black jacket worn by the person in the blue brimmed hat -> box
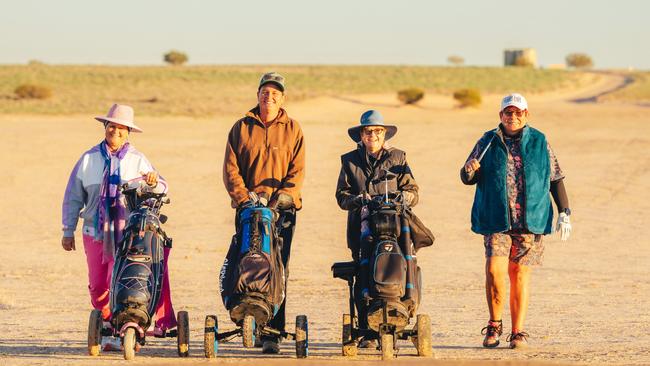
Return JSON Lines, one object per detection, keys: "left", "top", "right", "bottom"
{"left": 336, "top": 144, "right": 418, "bottom": 251}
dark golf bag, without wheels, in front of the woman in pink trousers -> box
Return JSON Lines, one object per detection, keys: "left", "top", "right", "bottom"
{"left": 110, "top": 185, "right": 172, "bottom": 329}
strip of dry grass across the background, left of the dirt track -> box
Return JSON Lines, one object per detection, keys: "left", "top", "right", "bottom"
{"left": 0, "top": 64, "right": 581, "bottom": 117}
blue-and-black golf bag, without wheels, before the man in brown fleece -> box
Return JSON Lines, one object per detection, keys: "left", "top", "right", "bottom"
{"left": 219, "top": 202, "right": 285, "bottom": 325}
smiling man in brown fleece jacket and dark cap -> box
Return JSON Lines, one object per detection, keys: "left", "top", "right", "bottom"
{"left": 223, "top": 72, "right": 305, "bottom": 353}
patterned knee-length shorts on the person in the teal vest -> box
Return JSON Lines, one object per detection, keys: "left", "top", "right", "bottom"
{"left": 483, "top": 231, "right": 544, "bottom": 266}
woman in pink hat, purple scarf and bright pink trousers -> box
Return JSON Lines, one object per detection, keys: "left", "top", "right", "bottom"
{"left": 61, "top": 104, "right": 176, "bottom": 350}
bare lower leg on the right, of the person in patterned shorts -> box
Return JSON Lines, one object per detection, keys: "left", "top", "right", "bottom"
{"left": 508, "top": 262, "right": 531, "bottom": 333}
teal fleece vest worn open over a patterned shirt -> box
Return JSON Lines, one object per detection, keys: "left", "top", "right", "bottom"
{"left": 472, "top": 126, "right": 553, "bottom": 235}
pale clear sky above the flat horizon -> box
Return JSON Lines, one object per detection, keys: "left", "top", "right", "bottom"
{"left": 0, "top": 0, "right": 650, "bottom": 69}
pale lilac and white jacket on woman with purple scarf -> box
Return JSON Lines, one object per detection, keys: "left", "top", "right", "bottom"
{"left": 63, "top": 145, "right": 167, "bottom": 240}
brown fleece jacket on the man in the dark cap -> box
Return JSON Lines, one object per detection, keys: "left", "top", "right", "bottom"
{"left": 223, "top": 106, "right": 305, "bottom": 210}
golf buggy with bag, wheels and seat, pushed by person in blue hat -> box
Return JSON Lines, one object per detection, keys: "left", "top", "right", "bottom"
{"left": 332, "top": 193, "right": 433, "bottom": 360}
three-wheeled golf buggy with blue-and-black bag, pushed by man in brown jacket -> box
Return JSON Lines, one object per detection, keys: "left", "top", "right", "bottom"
{"left": 204, "top": 194, "right": 309, "bottom": 358}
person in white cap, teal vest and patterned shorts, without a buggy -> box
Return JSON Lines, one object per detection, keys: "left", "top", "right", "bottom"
{"left": 460, "top": 93, "right": 571, "bottom": 349}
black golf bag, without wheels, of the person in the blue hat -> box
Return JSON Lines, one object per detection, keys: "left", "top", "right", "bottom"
{"left": 359, "top": 199, "right": 422, "bottom": 330}
